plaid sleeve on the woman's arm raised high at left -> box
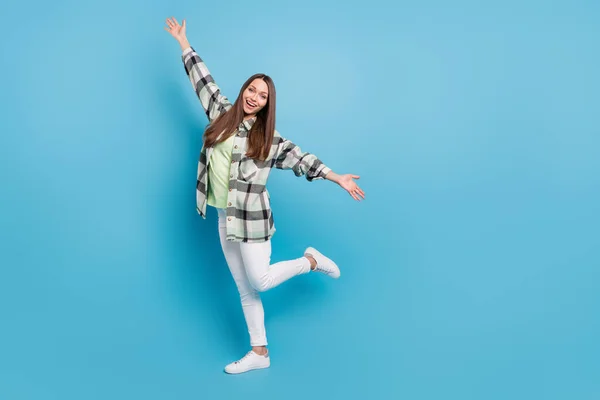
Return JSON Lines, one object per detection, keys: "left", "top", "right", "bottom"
{"left": 181, "top": 47, "right": 231, "bottom": 123}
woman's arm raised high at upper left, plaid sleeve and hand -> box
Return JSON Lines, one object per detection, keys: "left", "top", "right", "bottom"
{"left": 165, "top": 18, "right": 231, "bottom": 123}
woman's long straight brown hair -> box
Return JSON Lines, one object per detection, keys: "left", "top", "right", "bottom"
{"left": 204, "top": 74, "right": 275, "bottom": 161}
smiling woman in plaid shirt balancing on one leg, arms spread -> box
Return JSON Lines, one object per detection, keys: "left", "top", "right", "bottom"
{"left": 165, "top": 18, "right": 365, "bottom": 374}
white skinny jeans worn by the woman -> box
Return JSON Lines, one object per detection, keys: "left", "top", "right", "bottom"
{"left": 217, "top": 208, "right": 310, "bottom": 346}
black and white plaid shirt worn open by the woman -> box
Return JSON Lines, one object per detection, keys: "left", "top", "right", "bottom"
{"left": 181, "top": 47, "right": 331, "bottom": 243}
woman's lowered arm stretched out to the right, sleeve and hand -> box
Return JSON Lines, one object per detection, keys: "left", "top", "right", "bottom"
{"left": 273, "top": 131, "right": 365, "bottom": 201}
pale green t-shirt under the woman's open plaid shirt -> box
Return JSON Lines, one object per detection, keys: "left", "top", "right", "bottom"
{"left": 206, "top": 135, "right": 235, "bottom": 208}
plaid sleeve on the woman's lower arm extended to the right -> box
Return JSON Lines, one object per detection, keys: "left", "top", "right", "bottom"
{"left": 273, "top": 135, "right": 331, "bottom": 182}
